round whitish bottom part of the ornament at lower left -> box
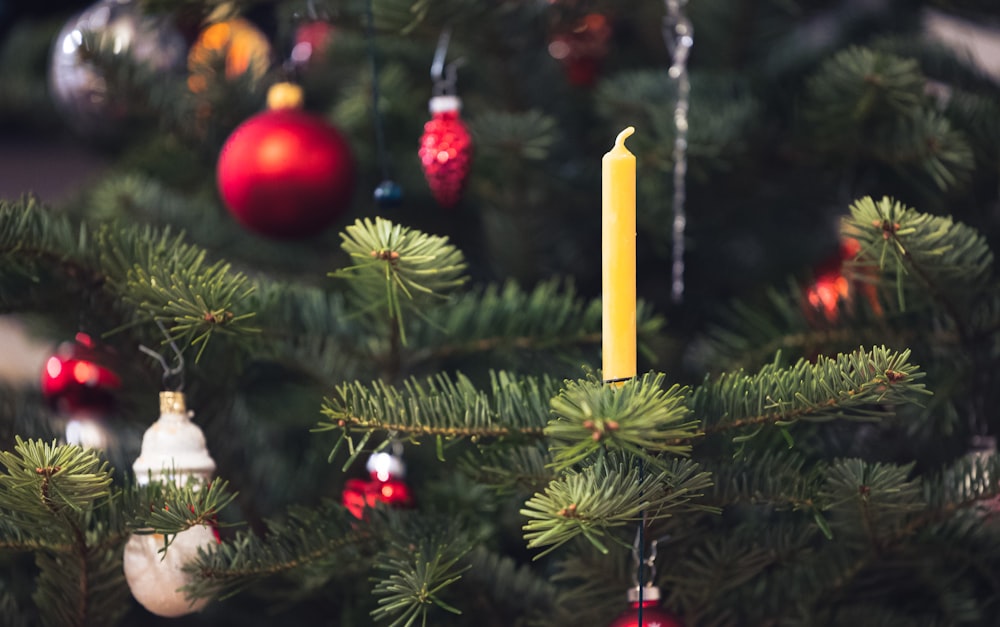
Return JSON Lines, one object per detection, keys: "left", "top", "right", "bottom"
{"left": 122, "top": 525, "right": 217, "bottom": 618}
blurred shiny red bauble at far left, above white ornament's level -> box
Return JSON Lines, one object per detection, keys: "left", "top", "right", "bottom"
{"left": 42, "top": 333, "right": 121, "bottom": 415}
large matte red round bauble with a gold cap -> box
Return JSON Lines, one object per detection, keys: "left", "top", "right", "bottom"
{"left": 216, "top": 109, "right": 355, "bottom": 239}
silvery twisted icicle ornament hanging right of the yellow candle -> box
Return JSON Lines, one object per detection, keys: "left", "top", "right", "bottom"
{"left": 663, "top": 0, "right": 694, "bottom": 303}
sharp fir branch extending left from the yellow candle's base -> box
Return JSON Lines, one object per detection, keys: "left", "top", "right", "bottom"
{"left": 316, "top": 371, "right": 557, "bottom": 463}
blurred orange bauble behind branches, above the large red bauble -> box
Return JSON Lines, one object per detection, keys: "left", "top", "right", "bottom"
{"left": 187, "top": 17, "right": 271, "bottom": 94}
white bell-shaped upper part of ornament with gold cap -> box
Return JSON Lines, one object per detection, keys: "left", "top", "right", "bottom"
{"left": 132, "top": 392, "right": 215, "bottom": 487}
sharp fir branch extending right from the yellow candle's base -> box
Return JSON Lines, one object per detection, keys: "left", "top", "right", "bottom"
{"left": 689, "top": 347, "right": 929, "bottom": 438}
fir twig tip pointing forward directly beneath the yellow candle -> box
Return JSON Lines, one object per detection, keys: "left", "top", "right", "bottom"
{"left": 545, "top": 373, "right": 698, "bottom": 470}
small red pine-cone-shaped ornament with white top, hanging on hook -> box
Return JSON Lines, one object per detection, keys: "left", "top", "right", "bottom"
{"left": 417, "top": 95, "right": 472, "bottom": 209}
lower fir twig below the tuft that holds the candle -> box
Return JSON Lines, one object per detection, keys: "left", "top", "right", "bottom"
{"left": 521, "top": 456, "right": 713, "bottom": 559}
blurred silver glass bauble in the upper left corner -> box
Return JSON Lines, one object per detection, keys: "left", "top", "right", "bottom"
{"left": 49, "top": 0, "right": 187, "bottom": 138}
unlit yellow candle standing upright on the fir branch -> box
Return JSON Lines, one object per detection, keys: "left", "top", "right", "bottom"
{"left": 601, "top": 126, "right": 636, "bottom": 382}
